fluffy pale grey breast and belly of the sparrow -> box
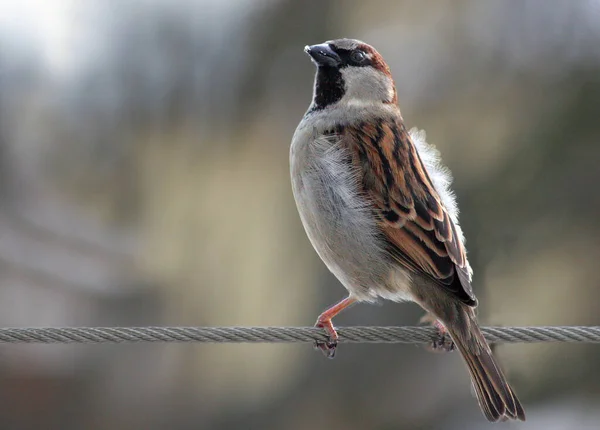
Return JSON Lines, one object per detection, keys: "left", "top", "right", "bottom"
{"left": 290, "top": 124, "right": 390, "bottom": 301}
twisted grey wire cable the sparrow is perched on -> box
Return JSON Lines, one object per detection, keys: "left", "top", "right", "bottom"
{"left": 0, "top": 326, "right": 600, "bottom": 344}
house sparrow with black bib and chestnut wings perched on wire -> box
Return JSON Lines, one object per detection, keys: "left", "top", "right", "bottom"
{"left": 290, "top": 39, "right": 525, "bottom": 421}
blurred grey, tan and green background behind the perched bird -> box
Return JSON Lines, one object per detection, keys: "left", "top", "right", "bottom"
{"left": 0, "top": 0, "right": 600, "bottom": 430}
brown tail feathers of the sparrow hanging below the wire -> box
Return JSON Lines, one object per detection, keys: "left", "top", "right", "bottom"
{"left": 446, "top": 318, "right": 525, "bottom": 422}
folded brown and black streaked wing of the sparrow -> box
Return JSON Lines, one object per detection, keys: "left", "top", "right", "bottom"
{"left": 342, "top": 119, "right": 477, "bottom": 306}
